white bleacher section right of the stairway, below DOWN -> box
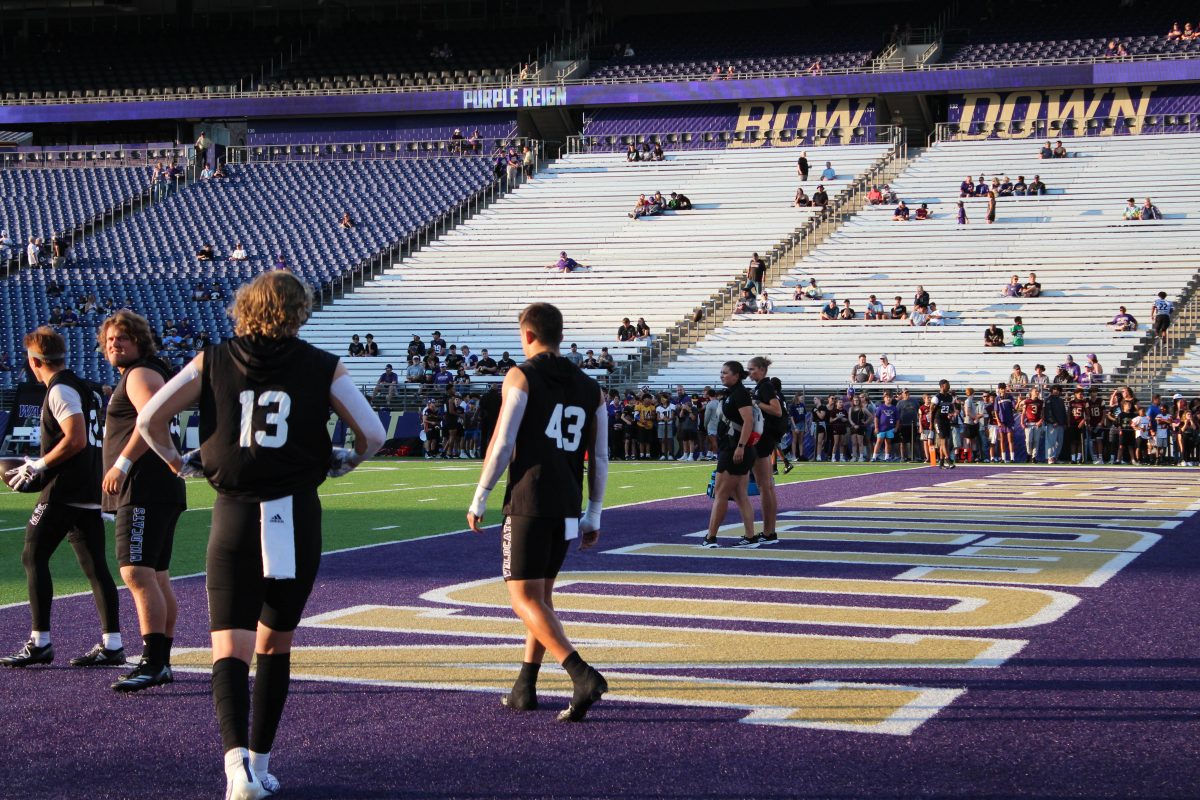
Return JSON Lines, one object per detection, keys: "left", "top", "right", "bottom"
{"left": 650, "top": 136, "right": 1200, "bottom": 389}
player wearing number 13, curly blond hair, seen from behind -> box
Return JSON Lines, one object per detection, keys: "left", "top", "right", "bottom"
{"left": 138, "top": 271, "right": 384, "bottom": 800}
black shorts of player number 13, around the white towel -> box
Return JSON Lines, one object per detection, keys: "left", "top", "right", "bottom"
{"left": 208, "top": 489, "right": 320, "bottom": 631}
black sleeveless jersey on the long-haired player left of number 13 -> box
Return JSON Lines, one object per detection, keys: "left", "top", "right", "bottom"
{"left": 102, "top": 356, "right": 187, "bottom": 512}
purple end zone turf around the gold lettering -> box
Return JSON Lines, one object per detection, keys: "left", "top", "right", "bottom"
{"left": 0, "top": 468, "right": 1200, "bottom": 798}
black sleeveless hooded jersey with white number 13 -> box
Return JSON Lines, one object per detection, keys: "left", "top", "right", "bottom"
{"left": 200, "top": 336, "right": 337, "bottom": 500}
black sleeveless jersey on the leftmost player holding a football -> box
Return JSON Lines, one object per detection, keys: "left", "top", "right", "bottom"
{"left": 37, "top": 369, "right": 103, "bottom": 506}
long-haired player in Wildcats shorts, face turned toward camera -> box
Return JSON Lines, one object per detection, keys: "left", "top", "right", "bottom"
{"left": 97, "top": 309, "right": 187, "bottom": 692}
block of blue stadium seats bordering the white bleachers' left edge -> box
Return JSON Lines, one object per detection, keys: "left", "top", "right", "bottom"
{"left": 0, "top": 157, "right": 492, "bottom": 385}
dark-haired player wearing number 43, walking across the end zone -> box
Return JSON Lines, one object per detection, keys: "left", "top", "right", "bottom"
{"left": 467, "top": 302, "right": 608, "bottom": 722}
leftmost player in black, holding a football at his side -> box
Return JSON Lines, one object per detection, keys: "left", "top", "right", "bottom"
{"left": 0, "top": 326, "right": 125, "bottom": 667}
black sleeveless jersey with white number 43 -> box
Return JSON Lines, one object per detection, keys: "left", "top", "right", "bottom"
{"left": 504, "top": 353, "right": 600, "bottom": 519}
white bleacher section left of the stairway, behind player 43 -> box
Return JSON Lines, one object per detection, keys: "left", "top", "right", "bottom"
{"left": 304, "top": 145, "right": 888, "bottom": 385}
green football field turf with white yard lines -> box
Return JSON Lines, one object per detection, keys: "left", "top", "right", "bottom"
{"left": 0, "top": 459, "right": 902, "bottom": 606}
